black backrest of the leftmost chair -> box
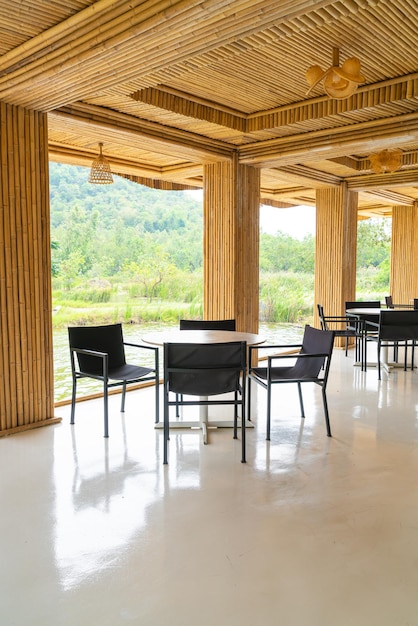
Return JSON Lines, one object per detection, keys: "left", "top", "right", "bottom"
{"left": 68, "top": 324, "right": 126, "bottom": 373}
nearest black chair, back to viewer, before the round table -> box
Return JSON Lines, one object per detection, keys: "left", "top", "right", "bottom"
{"left": 163, "top": 341, "right": 247, "bottom": 464}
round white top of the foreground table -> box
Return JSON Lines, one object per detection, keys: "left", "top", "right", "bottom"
{"left": 142, "top": 330, "right": 265, "bottom": 346}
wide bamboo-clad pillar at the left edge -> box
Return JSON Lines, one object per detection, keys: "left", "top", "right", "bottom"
{"left": 0, "top": 103, "right": 57, "bottom": 435}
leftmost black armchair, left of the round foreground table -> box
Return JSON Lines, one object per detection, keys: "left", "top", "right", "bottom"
{"left": 68, "top": 324, "right": 159, "bottom": 437}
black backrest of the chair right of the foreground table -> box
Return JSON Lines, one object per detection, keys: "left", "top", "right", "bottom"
{"left": 294, "top": 325, "right": 334, "bottom": 378}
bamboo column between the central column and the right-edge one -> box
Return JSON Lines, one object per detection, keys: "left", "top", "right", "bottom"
{"left": 314, "top": 184, "right": 357, "bottom": 346}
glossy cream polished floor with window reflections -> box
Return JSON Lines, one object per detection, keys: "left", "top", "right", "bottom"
{"left": 0, "top": 351, "right": 418, "bottom": 626}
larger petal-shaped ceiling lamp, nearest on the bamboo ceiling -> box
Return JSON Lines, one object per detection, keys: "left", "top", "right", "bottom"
{"left": 306, "top": 48, "right": 366, "bottom": 100}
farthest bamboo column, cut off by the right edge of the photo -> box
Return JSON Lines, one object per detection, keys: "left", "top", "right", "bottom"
{"left": 390, "top": 202, "right": 418, "bottom": 304}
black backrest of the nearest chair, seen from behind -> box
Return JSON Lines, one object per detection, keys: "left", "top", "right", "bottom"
{"left": 164, "top": 341, "right": 247, "bottom": 396}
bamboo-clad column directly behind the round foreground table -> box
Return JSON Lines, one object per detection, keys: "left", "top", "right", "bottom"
{"left": 204, "top": 158, "right": 260, "bottom": 333}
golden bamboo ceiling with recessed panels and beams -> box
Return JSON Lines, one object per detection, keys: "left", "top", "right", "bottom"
{"left": 0, "top": 0, "right": 418, "bottom": 216}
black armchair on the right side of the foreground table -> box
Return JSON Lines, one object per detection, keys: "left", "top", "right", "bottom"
{"left": 248, "top": 326, "right": 334, "bottom": 440}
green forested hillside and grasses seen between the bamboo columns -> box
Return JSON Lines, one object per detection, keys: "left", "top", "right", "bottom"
{"left": 50, "top": 163, "right": 391, "bottom": 326}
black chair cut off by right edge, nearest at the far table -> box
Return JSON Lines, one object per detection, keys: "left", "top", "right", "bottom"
{"left": 365, "top": 310, "right": 418, "bottom": 380}
